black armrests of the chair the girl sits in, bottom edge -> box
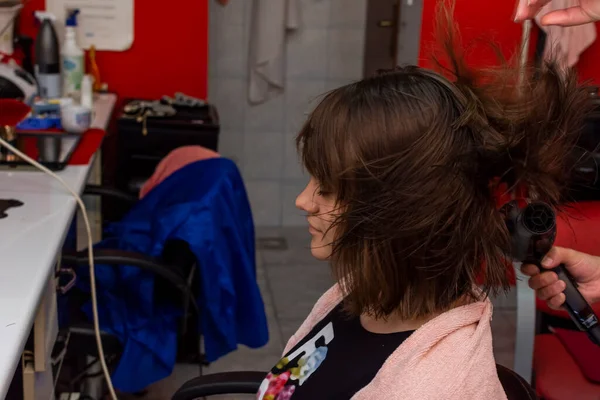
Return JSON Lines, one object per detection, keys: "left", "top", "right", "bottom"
{"left": 171, "top": 365, "right": 538, "bottom": 400}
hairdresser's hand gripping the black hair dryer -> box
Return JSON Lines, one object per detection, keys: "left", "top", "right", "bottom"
{"left": 521, "top": 247, "right": 600, "bottom": 308}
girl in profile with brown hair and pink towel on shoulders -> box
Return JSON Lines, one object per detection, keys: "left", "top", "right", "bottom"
{"left": 258, "top": 3, "right": 588, "bottom": 400}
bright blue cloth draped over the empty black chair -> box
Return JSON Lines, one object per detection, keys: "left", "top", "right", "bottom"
{"left": 72, "top": 158, "right": 268, "bottom": 393}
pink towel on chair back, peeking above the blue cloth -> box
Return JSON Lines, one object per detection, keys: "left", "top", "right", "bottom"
{"left": 140, "top": 146, "right": 220, "bottom": 199}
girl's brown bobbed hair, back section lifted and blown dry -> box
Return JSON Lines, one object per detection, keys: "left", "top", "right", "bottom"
{"left": 297, "top": 0, "right": 589, "bottom": 318}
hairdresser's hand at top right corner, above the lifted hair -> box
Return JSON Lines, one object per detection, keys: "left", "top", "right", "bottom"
{"left": 515, "top": 0, "right": 600, "bottom": 26}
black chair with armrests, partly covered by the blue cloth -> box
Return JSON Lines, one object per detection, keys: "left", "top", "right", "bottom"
{"left": 58, "top": 186, "right": 203, "bottom": 399}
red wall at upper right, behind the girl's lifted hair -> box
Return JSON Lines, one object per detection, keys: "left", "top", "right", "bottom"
{"left": 419, "top": 0, "right": 600, "bottom": 84}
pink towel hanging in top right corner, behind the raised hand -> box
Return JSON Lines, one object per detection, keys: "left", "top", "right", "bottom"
{"left": 536, "top": 0, "right": 596, "bottom": 67}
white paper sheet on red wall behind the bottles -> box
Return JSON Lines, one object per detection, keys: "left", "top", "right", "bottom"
{"left": 46, "top": 0, "right": 134, "bottom": 51}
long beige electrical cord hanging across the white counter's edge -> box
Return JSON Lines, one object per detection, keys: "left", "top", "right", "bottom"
{"left": 0, "top": 138, "right": 118, "bottom": 400}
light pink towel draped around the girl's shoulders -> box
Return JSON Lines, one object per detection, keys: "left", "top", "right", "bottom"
{"left": 284, "top": 285, "right": 506, "bottom": 400}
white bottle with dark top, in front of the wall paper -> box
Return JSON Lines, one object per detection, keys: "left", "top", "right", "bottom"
{"left": 61, "top": 10, "right": 85, "bottom": 97}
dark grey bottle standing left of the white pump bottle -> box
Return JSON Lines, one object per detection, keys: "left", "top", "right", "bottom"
{"left": 34, "top": 11, "right": 62, "bottom": 99}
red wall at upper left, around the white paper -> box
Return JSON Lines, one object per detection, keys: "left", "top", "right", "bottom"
{"left": 21, "top": 0, "right": 208, "bottom": 98}
